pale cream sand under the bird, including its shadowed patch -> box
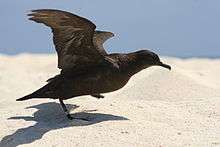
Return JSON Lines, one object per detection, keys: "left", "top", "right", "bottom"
{"left": 0, "top": 54, "right": 220, "bottom": 147}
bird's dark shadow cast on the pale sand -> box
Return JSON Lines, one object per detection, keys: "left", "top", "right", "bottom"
{"left": 0, "top": 102, "right": 128, "bottom": 147}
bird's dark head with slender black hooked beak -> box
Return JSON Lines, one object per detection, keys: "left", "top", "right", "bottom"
{"left": 134, "top": 50, "right": 171, "bottom": 70}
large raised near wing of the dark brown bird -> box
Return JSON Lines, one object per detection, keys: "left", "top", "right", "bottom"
{"left": 28, "top": 9, "right": 104, "bottom": 69}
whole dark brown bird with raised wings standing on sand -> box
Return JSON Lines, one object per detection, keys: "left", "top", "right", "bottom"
{"left": 17, "top": 9, "right": 171, "bottom": 119}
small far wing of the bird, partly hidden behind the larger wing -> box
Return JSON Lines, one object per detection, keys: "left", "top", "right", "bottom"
{"left": 93, "top": 31, "right": 114, "bottom": 55}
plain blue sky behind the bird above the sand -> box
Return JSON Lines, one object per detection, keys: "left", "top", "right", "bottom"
{"left": 0, "top": 0, "right": 220, "bottom": 57}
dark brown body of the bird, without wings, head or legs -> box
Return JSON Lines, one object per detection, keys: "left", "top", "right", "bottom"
{"left": 18, "top": 54, "right": 145, "bottom": 100}
